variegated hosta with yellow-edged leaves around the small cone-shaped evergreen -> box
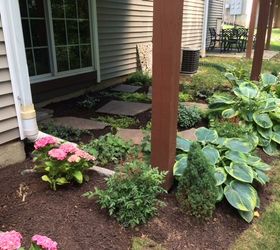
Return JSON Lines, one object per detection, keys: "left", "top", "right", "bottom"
{"left": 173, "top": 127, "right": 270, "bottom": 222}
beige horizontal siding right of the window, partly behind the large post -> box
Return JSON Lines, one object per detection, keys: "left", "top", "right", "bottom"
{"left": 97, "top": 0, "right": 204, "bottom": 80}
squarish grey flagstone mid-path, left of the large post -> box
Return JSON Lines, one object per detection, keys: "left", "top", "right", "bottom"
{"left": 96, "top": 100, "right": 152, "bottom": 116}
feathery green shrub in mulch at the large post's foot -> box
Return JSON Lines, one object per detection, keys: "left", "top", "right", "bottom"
{"left": 85, "top": 161, "right": 165, "bottom": 227}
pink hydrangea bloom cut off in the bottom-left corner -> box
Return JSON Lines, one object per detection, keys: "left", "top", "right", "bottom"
{"left": 0, "top": 231, "right": 22, "bottom": 250}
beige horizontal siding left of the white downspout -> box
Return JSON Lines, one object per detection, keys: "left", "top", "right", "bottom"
{"left": 0, "top": 17, "right": 19, "bottom": 145}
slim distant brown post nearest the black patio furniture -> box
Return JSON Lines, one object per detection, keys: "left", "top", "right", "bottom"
{"left": 246, "top": 0, "right": 259, "bottom": 59}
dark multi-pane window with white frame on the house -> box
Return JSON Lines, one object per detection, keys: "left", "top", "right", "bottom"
{"left": 19, "top": 0, "right": 93, "bottom": 79}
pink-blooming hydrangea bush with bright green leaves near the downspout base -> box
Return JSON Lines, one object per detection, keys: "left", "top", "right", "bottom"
{"left": 33, "top": 136, "right": 95, "bottom": 190}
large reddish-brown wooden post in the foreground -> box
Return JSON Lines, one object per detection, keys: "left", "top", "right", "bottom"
{"left": 152, "top": 0, "right": 184, "bottom": 189}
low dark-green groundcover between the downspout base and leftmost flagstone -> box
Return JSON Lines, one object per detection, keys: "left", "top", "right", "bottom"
{"left": 39, "top": 122, "right": 90, "bottom": 142}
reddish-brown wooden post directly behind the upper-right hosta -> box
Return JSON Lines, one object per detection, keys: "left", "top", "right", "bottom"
{"left": 251, "top": 0, "right": 270, "bottom": 81}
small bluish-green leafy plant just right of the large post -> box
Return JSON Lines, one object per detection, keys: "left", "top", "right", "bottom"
{"left": 178, "top": 104, "right": 202, "bottom": 128}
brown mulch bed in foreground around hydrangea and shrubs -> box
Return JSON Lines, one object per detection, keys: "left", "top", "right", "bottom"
{"left": 0, "top": 155, "right": 276, "bottom": 250}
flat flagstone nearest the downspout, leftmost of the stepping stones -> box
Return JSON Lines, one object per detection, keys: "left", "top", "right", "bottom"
{"left": 43, "top": 116, "right": 109, "bottom": 130}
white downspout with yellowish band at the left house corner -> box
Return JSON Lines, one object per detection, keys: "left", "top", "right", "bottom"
{"left": 0, "top": 0, "right": 39, "bottom": 141}
